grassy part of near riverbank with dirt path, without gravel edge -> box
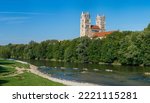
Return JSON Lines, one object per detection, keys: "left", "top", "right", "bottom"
{"left": 0, "top": 59, "right": 63, "bottom": 86}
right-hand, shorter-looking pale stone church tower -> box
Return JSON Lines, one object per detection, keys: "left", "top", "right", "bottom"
{"left": 96, "top": 15, "right": 106, "bottom": 32}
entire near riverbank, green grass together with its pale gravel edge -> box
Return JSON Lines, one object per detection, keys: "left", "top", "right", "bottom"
{"left": 0, "top": 59, "right": 99, "bottom": 86}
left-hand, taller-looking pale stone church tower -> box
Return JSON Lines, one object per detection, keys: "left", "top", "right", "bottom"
{"left": 80, "top": 12, "right": 91, "bottom": 37}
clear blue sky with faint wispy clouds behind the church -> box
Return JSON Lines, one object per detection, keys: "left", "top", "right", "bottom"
{"left": 0, "top": 0, "right": 150, "bottom": 45}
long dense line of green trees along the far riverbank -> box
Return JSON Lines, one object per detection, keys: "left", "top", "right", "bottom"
{"left": 0, "top": 25, "right": 150, "bottom": 65}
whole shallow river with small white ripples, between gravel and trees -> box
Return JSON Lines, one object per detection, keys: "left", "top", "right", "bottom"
{"left": 26, "top": 60, "right": 150, "bottom": 86}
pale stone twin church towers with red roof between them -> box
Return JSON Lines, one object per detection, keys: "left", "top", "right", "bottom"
{"left": 80, "top": 12, "right": 105, "bottom": 38}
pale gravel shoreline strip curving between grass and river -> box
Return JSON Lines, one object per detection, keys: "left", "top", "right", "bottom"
{"left": 15, "top": 60, "right": 100, "bottom": 86}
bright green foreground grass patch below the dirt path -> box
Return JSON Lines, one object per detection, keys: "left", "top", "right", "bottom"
{"left": 1, "top": 72, "right": 63, "bottom": 86}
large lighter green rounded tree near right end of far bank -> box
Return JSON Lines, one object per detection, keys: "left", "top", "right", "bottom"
{"left": 118, "top": 32, "right": 142, "bottom": 65}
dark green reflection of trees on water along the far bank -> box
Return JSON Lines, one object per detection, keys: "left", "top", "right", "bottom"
{"left": 25, "top": 60, "right": 150, "bottom": 73}
